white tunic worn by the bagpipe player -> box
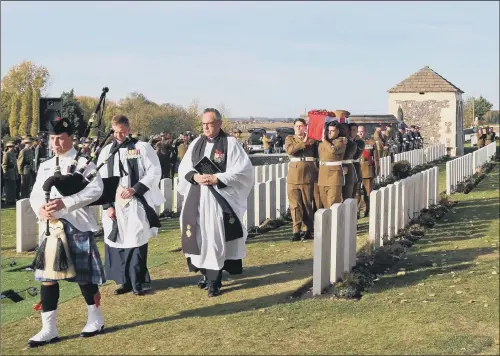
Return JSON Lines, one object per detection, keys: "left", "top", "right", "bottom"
{"left": 30, "top": 148, "right": 103, "bottom": 237}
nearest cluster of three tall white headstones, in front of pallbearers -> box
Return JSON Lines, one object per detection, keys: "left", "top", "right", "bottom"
{"left": 312, "top": 199, "right": 358, "bottom": 295}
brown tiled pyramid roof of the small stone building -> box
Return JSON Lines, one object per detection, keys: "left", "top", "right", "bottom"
{"left": 388, "top": 66, "right": 463, "bottom": 93}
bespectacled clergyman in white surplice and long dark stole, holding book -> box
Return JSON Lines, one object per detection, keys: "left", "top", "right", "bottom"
{"left": 177, "top": 108, "right": 254, "bottom": 297}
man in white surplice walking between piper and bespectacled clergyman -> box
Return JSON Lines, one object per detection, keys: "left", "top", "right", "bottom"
{"left": 98, "top": 115, "right": 165, "bottom": 295}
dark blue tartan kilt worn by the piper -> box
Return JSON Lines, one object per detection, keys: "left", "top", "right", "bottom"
{"left": 35, "top": 219, "right": 106, "bottom": 285}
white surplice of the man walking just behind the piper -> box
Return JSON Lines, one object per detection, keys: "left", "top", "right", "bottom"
{"left": 97, "top": 141, "right": 165, "bottom": 248}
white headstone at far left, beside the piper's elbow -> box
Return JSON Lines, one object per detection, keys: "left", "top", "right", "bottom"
{"left": 16, "top": 199, "right": 38, "bottom": 253}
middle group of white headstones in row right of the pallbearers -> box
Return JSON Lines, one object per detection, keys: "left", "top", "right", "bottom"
{"left": 368, "top": 167, "right": 439, "bottom": 249}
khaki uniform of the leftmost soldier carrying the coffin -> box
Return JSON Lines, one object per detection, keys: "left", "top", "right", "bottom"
{"left": 285, "top": 135, "right": 318, "bottom": 233}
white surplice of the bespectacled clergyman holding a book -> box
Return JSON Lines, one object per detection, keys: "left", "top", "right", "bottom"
{"left": 177, "top": 137, "right": 254, "bottom": 270}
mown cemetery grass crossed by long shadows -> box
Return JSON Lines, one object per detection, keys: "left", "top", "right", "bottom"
{"left": 1, "top": 144, "right": 500, "bottom": 355}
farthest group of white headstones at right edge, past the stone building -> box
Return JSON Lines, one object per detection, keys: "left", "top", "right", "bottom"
{"left": 446, "top": 142, "right": 496, "bottom": 195}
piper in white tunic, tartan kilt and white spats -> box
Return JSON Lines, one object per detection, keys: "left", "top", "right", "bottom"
{"left": 28, "top": 117, "right": 105, "bottom": 347}
